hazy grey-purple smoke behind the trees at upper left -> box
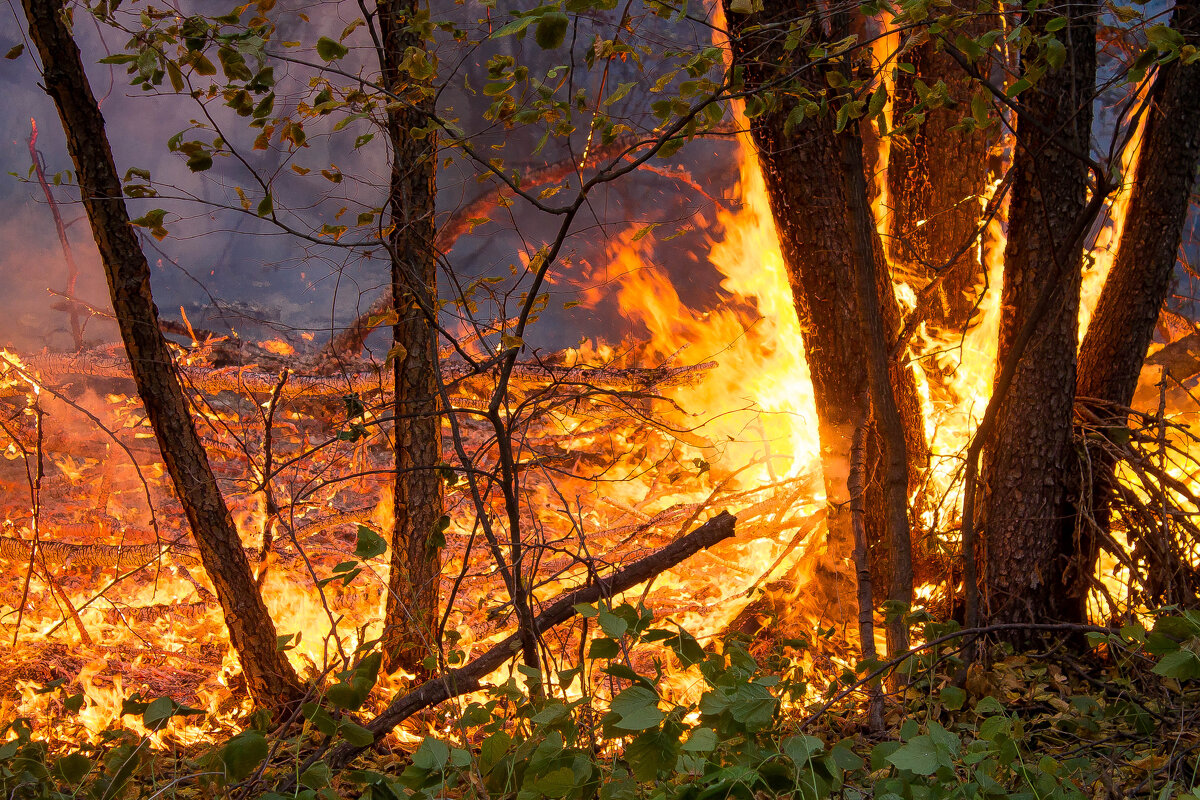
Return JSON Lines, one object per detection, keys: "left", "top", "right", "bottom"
{"left": 0, "top": 1, "right": 736, "bottom": 351}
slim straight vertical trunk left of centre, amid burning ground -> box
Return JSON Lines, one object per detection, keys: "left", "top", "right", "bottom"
{"left": 376, "top": 0, "right": 443, "bottom": 676}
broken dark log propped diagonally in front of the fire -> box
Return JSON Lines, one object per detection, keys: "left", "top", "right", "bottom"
{"left": 304, "top": 511, "right": 737, "bottom": 774}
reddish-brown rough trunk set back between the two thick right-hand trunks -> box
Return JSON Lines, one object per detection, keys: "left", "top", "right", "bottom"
{"left": 888, "top": 16, "right": 998, "bottom": 331}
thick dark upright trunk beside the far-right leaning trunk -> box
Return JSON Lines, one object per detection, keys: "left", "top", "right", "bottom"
{"left": 983, "top": 2, "right": 1098, "bottom": 622}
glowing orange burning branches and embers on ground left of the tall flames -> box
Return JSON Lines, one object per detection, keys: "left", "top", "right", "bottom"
{"left": 0, "top": 338, "right": 816, "bottom": 730}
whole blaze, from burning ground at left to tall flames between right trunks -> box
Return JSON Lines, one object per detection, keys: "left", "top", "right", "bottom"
{"left": 0, "top": 120, "right": 1196, "bottom": 742}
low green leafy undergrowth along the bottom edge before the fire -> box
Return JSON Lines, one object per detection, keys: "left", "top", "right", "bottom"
{"left": 0, "top": 604, "right": 1200, "bottom": 800}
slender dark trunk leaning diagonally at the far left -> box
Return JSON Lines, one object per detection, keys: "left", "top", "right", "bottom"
{"left": 22, "top": 0, "right": 304, "bottom": 708}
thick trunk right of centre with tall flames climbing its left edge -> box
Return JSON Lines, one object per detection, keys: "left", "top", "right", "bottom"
{"left": 725, "top": 0, "right": 928, "bottom": 652}
